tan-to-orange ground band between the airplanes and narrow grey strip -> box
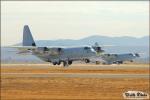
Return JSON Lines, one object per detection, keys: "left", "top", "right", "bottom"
{"left": 1, "top": 64, "right": 149, "bottom": 74}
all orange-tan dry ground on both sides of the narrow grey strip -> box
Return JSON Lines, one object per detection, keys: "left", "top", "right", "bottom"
{"left": 1, "top": 64, "right": 150, "bottom": 100}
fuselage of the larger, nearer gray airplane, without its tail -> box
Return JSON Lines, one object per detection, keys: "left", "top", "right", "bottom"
{"left": 32, "top": 47, "right": 96, "bottom": 65}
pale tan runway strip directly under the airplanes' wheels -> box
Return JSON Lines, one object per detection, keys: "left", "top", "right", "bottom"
{"left": 1, "top": 64, "right": 149, "bottom": 70}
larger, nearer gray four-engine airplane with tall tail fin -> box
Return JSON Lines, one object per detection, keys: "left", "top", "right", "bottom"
{"left": 17, "top": 25, "right": 101, "bottom": 66}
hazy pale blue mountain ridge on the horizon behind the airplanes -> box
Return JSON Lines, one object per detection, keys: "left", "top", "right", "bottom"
{"left": 17, "top": 35, "right": 149, "bottom": 46}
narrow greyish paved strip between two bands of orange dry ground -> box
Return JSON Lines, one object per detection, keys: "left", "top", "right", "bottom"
{"left": 1, "top": 73, "right": 149, "bottom": 79}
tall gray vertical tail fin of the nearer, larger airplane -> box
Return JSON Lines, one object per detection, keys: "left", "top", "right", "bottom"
{"left": 22, "top": 25, "right": 36, "bottom": 46}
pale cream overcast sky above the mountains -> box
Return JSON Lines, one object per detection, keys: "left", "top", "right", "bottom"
{"left": 1, "top": 1, "right": 149, "bottom": 45}
